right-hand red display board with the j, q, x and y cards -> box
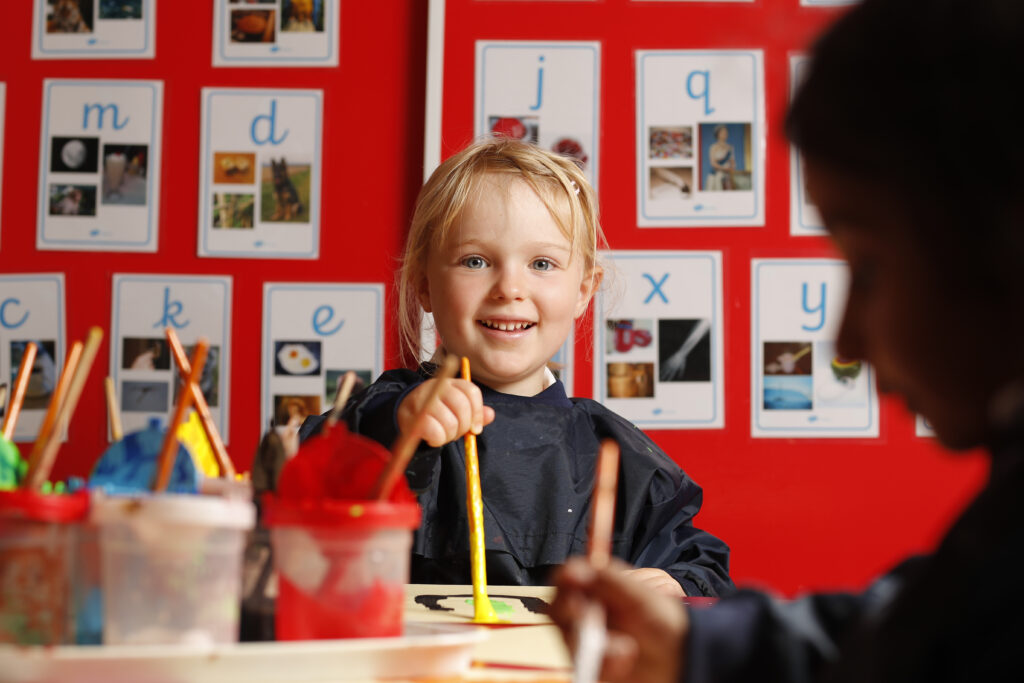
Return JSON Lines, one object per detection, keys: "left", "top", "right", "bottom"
{"left": 426, "top": 0, "right": 984, "bottom": 593}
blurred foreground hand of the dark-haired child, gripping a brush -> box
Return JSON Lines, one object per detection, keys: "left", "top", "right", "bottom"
{"left": 550, "top": 558, "right": 689, "bottom": 683}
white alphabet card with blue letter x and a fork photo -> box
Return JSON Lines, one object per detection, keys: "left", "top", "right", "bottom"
{"left": 594, "top": 251, "right": 725, "bottom": 429}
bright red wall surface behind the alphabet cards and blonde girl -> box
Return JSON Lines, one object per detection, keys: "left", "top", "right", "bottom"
{"left": 0, "top": 0, "right": 985, "bottom": 594}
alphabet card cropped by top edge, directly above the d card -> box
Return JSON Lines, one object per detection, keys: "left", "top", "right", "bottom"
{"left": 213, "top": 0, "right": 340, "bottom": 67}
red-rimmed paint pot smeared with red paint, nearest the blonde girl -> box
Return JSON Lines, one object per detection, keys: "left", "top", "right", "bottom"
{"left": 263, "top": 496, "right": 420, "bottom": 640}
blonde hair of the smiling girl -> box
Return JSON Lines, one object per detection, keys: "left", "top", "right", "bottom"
{"left": 398, "top": 137, "right": 606, "bottom": 365}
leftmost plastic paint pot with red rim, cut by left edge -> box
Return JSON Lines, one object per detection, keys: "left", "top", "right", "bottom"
{"left": 0, "top": 489, "right": 89, "bottom": 645}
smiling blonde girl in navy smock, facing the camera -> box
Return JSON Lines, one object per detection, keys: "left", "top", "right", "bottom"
{"left": 317, "top": 138, "right": 732, "bottom": 596}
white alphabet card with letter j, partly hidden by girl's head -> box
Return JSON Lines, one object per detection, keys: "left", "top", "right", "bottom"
{"left": 474, "top": 40, "right": 601, "bottom": 186}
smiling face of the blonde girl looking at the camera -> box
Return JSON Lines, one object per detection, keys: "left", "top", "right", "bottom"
{"left": 420, "top": 173, "right": 600, "bottom": 396}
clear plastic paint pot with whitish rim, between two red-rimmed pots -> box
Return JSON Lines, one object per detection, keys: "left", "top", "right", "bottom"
{"left": 92, "top": 494, "right": 256, "bottom": 645}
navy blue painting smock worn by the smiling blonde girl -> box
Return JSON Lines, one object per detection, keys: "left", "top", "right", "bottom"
{"left": 303, "top": 366, "right": 733, "bottom": 596}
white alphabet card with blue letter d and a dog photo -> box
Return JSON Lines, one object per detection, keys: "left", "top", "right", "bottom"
{"left": 199, "top": 88, "right": 324, "bottom": 259}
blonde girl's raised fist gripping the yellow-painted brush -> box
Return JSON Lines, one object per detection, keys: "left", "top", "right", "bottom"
{"left": 397, "top": 379, "right": 495, "bottom": 447}
